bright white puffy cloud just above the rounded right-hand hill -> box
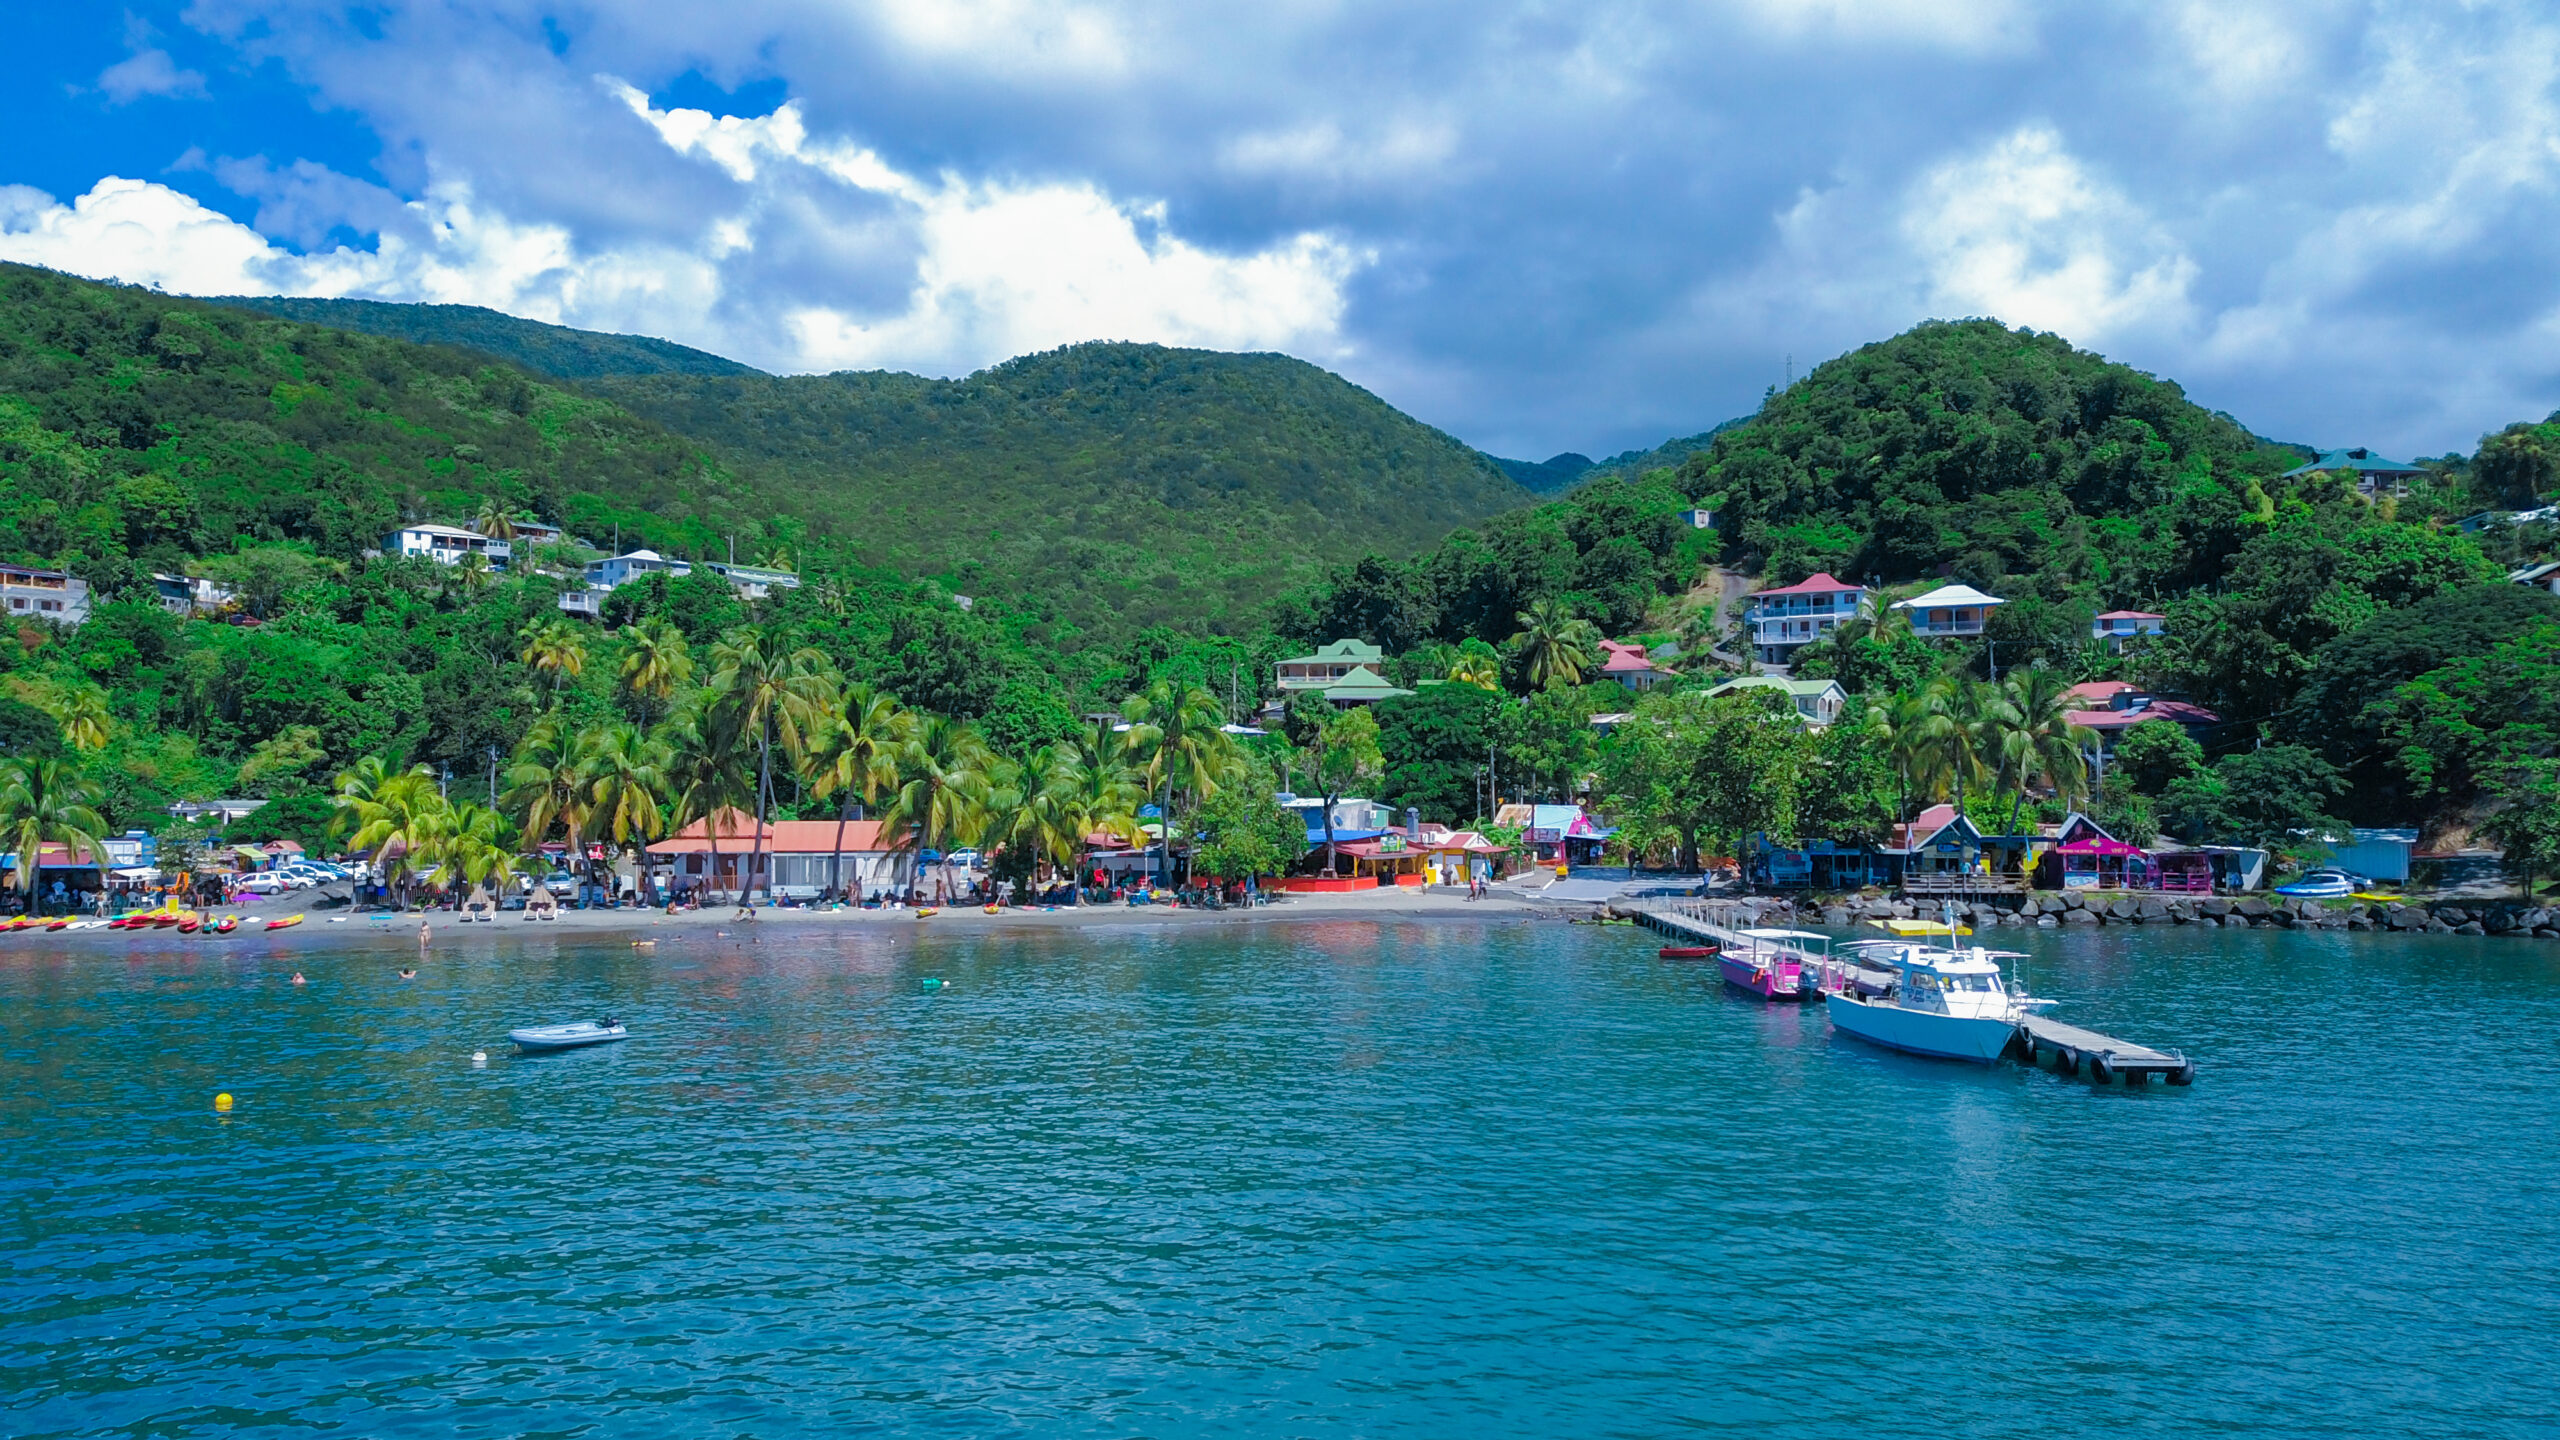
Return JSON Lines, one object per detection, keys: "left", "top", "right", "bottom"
{"left": 1900, "top": 126, "right": 2196, "bottom": 343}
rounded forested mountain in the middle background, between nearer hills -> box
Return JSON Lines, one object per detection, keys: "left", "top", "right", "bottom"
{"left": 589, "top": 343, "right": 1528, "bottom": 630}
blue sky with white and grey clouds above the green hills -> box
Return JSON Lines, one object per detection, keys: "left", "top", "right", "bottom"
{"left": 0, "top": 0, "right": 2560, "bottom": 459}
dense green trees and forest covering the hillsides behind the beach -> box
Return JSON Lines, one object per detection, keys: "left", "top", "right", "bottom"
{"left": 0, "top": 266, "right": 2560, "bottom": 881}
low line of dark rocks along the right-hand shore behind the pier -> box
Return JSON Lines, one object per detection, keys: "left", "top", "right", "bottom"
{"left": 1802, "top": 889, "right": 2560, "bottom": 940}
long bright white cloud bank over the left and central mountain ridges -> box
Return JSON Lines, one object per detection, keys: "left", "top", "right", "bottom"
{"left": 0, "top": 82, "right": 1367, "bottom": 372}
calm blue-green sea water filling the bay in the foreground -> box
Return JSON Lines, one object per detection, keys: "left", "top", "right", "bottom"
{"left": 0, "top": 922, "right": 2560, "bottom": 1440}
